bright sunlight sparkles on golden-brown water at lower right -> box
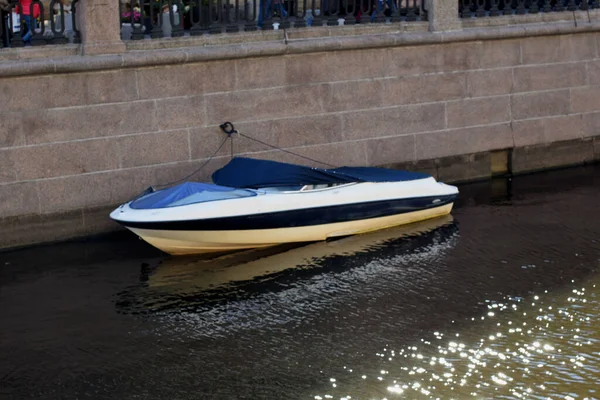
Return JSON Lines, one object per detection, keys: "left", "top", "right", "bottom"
{"left": 315, "top": 282, "right": 600, "bottom": 399}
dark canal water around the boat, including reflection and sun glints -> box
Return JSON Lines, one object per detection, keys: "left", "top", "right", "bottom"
{"left": 0, "top": 166, "right": 600, "bottom": 400}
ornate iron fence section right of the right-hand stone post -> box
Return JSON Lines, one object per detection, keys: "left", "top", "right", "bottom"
{"left": 459, "top": 0, "right": 600, "bottom": 18}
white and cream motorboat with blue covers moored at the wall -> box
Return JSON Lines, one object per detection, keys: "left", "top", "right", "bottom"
{"left": 110, "top": 157, "right": 458, "bottom": 255}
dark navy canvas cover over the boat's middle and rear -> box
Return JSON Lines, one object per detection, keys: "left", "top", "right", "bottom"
{"left": 212, "top": 157, "right": 431, "bottom": 189}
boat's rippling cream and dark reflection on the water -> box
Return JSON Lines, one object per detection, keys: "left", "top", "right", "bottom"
{"left": 119, "top": 215, "right": 458, "bottom": 313}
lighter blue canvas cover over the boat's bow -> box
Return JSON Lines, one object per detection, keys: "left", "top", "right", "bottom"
{"left": 129, "top": 182, "right": 256, "bottom": 210}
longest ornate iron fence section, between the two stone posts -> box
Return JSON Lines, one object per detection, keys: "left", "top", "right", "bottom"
{"left": 120, "top": 0, "right": 427, "bottom": 40}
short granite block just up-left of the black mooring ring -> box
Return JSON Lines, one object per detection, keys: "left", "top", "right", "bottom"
{"left": 156, "top": 96, "right": 206, "bottom": 130}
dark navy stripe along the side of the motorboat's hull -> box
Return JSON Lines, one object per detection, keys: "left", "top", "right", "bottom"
{"left": 117, "top": 195, "right": 456, "bottom": 231}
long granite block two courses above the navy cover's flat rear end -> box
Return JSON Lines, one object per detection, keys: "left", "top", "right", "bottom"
{"left": 342, "top": 103, "right": 446, "bottom": 140}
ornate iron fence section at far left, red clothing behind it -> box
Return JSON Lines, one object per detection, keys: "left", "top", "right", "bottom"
{"left": 0, "top": 0, "right": 81, "bottom": 47}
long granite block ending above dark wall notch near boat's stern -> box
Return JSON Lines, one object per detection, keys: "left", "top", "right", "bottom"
{"left": 415, "top": 124, "right": 513, "bottom": 160}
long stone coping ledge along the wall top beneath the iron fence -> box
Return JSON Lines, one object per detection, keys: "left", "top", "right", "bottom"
{"left": 0, "top": 18, "right": 600, "bottom": 77}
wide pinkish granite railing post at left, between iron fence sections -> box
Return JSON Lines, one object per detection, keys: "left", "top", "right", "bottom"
{"left": 77, "top": 0, "right": 125, "bottom": 55}
